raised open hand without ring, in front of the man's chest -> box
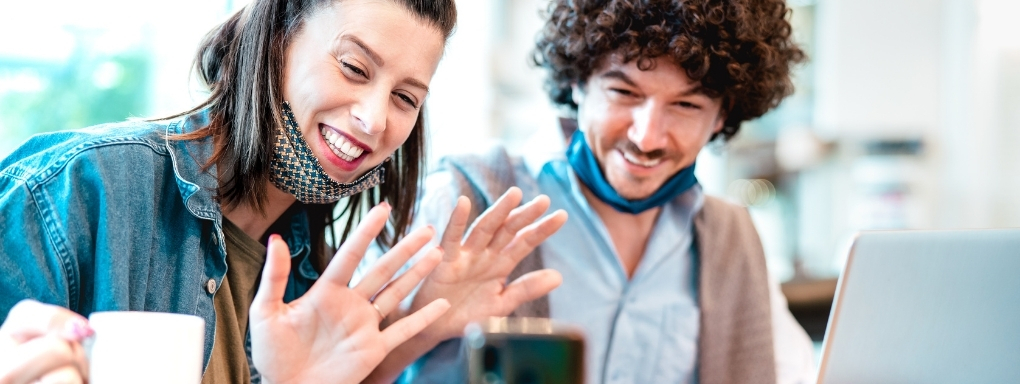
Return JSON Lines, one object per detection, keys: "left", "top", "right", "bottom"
{"left": 366, "top": 187, "right": 567, "bottom": 383}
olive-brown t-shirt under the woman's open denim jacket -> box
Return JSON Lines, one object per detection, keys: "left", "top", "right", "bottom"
{"left": 202, "top": 218, "right": 266, "bottom": 384}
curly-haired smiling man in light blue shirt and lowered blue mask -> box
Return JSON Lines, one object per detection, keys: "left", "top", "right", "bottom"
{"left": 359, "top": 0, "right": 814, "bottom": 383}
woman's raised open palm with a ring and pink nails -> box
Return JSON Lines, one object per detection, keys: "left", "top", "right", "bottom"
{"left": 250, "top": 203, "right": 450, "bottom": 384}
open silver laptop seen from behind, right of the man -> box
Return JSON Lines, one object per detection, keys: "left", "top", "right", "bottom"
{"left": 818, "top": 229, "right": 1020, "bottom": 384}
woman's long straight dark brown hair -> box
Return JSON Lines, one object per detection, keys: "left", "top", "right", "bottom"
{"left": 171, "top": 0, "right": 457, "bottom": 252}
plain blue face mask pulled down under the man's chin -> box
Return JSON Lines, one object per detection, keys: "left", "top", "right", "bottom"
{"left": 567, "top": 130, "right": 698, "bottom": 214}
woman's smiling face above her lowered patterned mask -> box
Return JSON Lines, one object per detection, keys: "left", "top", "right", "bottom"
{"left": 284, "top": 0, "right": 444, "bottom": 183}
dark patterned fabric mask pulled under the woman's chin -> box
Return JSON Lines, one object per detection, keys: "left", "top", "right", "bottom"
{"left": 270, "top": 102, "right": 389, "bottom": 204}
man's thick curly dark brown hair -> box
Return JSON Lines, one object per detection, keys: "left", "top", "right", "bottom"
{"left": 533, "top": 0, "right": 805, "bottom": 140}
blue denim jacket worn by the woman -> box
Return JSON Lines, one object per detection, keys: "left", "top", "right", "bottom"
{"left": 0, "top": 112, "right": 318, "bottom": 372}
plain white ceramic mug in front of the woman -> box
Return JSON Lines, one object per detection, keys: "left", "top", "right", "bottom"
{"left": 88, "top": 311, "right": 205, "bottom": 384}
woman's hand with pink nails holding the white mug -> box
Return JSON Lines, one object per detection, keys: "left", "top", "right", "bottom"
{"left": 0, "top": 300, "right": 94, "bottom": 384}
